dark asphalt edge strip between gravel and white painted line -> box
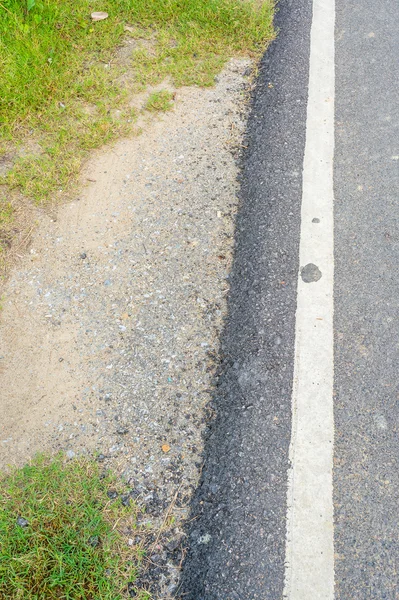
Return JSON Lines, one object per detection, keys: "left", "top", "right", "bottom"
{"left": 180, "top": 0, "right": 311, "bottom": 600}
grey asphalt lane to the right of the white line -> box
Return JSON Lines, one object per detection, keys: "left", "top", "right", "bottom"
{"left": 334, "top": 0, "right": 399, "bottom": 600}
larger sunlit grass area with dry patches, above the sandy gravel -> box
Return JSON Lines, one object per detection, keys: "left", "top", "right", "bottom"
{"left": 0, "top": 0, "right": 274, "bottom": 256}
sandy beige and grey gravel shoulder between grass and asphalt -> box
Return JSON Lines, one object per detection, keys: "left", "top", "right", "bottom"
{"left": 0, "top": 59, "right": 250, "bottom": 598}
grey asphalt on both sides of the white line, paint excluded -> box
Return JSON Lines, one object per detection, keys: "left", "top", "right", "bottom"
{"left": 180, "top": 0, "right": 399, "bottom": 600}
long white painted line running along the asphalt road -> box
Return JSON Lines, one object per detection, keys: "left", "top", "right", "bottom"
{"left": 284, "top": 0, "right": 335, "bottom": 600}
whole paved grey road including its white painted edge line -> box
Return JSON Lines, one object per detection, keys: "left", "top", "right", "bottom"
{"left": 180, "top": 0, "right": 399, "bottom": 600}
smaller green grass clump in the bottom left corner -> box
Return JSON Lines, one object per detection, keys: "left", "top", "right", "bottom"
{"left": 0, "top": 455, "right": 150, "bottom": 600}
